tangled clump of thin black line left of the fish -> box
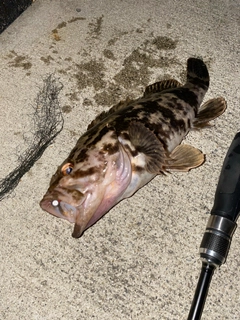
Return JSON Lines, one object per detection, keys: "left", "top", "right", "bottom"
{"left": 0, "top": 75, "right": 63, "bottom": 201}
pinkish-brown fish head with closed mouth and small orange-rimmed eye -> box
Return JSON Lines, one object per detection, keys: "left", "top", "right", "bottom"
{"left": 40, "top": 142, "right": 132, "bottom": 238}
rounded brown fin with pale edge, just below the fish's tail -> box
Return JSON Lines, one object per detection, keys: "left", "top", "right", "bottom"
{"left": 193, "top": 97, "right": 227, "bottom": 129}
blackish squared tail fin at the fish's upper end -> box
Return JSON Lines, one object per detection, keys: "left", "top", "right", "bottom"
{"left": 187, "top": 58, "right": 209, "bottom": 88}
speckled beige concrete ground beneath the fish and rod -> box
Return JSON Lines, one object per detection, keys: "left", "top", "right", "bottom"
{"left": 0, "top": 0, "right": 240, "bottom": 320}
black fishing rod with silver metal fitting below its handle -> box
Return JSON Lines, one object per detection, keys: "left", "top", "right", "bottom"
{"left": 187, "top": 132, "right": 240, "bottom": 320}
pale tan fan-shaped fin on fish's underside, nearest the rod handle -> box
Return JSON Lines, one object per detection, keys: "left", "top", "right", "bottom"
{"left": 165, "top": 144, "right": 205, "bottom": 171}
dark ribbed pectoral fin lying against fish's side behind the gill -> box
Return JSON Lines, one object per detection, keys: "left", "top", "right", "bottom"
{"left": 128, "top": 121, "right": 165, "bottom": 174}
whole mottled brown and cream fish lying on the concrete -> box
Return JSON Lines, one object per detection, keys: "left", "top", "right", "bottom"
{"left": 40, "top": 57, "right": 227, "bottom": 238}
